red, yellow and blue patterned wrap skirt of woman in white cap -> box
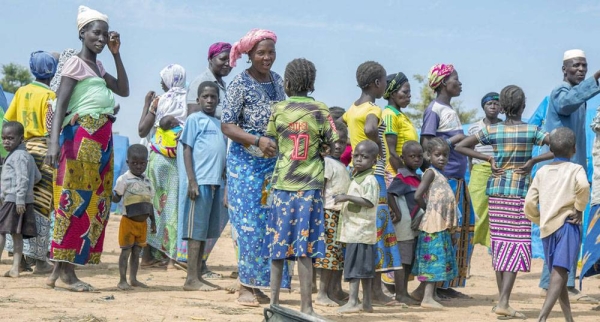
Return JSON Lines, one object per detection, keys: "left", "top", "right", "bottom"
{"left": 50, "top": 115, "right": 113, "bottom": 265}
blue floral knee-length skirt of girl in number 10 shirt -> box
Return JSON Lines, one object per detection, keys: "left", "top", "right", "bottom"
{"left": 263, "top": 189, "right": 325, "bottom": 259}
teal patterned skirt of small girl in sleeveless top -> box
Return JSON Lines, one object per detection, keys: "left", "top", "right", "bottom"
{"left": 412, "top": 230, "right": 458, "bottom": 282}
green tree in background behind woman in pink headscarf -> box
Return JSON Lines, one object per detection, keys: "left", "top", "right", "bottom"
{"left": 406, "top": 74, "right": 477, "bottom": 128}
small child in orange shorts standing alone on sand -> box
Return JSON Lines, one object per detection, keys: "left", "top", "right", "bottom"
{"left": 112, "top": 144, "right": 156, "bottom": 290}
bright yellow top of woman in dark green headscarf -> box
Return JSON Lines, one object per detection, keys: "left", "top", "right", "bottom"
{"left": 381, "top": 105, "right": 419, "bottom": 176}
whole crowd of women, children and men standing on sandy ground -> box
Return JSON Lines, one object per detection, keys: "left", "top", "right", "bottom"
{"left": 0, "top": 6, "right": 600, "bottom": 321}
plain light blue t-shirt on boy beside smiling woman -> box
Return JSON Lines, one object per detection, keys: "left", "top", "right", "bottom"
{"left": 177, "top": 112, "right": 227, "bottom": 185}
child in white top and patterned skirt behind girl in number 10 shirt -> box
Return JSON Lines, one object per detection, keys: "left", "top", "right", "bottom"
{"left": 314, "top": 121, "right": 351, "bottom": 306}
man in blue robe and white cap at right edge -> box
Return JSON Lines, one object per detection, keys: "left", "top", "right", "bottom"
{"left": 540, "top": 49, "right": 600, "bottom": 303}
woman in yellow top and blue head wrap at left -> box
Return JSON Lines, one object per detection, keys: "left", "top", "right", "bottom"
{"left": 4, "top": 51, "right": 58, "bottom": 274}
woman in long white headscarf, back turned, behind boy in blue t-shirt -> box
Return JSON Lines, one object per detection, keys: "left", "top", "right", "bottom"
{"left": 138, "top": 64, "right": 187, "bottom": 266}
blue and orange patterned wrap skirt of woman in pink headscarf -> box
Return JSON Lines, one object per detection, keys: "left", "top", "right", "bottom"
{"left": 439, "top": 179, "right": 475, "bottom": 288}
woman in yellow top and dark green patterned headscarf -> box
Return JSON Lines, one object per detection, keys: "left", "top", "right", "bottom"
{"left": 382, "top": 72, "right": 419, "bottom": 185}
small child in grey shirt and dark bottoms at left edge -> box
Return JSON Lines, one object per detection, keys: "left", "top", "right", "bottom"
{"left": 0, "top": 121, "right": 42, "bottom": 277}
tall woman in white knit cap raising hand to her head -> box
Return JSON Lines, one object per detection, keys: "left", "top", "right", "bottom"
{"left": 46, "top": 6, "right": 129, "bottom": 292}
